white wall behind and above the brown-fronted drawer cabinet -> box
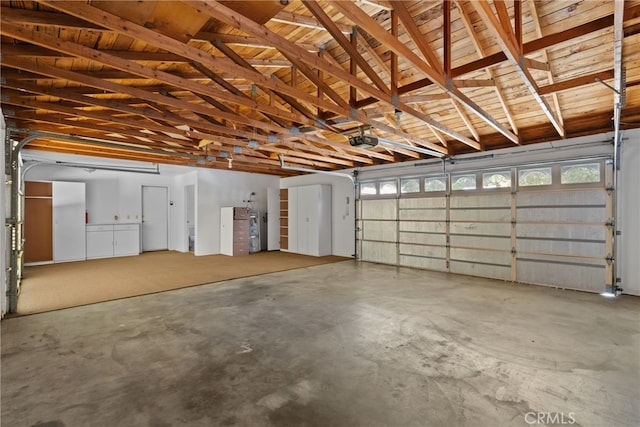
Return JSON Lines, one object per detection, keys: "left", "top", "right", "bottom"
{"left": 194, "top": 169, "right": 280, "bottom": 255}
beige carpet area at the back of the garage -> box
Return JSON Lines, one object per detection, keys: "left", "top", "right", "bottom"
{"left": 18, "top": 251, "right": 349, "bottom": 314}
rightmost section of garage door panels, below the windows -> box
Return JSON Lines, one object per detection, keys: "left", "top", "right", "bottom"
{"left": 516, "top": 189, "right": 610, "bottom": 292}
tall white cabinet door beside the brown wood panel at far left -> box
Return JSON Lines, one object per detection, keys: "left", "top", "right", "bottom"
{"left": 52, "top": 181, "right": 86, "bottom": 262}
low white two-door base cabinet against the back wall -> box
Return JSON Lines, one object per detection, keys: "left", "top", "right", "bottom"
{"left": 87, "top": 224, "right": 140, "bottom": 259}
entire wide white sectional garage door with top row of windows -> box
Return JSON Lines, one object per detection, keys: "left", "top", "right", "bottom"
{"left": 357, "top": 161, "right": 612, "bottom": 292}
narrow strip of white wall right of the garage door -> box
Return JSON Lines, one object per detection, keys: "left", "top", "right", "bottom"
{"left": 616, "top": 129, "right": 640, "bottom": 295}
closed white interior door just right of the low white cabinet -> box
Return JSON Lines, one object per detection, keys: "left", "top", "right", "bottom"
{"left": 142, "top": 186, "right": 169, "bottom": 252}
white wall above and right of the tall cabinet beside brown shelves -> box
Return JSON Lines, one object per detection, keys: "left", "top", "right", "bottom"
{"left": 280, "top": 174, "right": 355, "bottom": 257}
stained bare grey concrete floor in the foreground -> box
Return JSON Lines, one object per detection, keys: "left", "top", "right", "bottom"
{"left": 2, "top": 261, "right": 640, "bottom": 427}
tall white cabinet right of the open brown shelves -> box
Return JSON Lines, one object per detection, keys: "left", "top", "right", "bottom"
{"left": 288, "top": 185, "right": 332, "bottom": 256}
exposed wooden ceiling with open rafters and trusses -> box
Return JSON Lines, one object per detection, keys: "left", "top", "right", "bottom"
{"left": 0, "top": 0, "right": 640, "bottom": 176}
